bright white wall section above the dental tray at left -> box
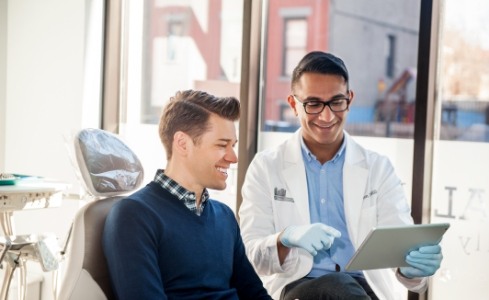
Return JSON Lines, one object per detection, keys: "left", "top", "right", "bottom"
{"left": 4, "top": 0, "right": 85, "bottom": 188}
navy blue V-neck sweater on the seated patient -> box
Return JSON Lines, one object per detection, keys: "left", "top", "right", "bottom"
{"left": 103, "top": 182, "right": 271, "bottom": 300}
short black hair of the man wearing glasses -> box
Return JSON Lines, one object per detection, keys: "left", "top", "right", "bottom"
{"left": 291, "top": 51, "right": 350, "bottom": 90}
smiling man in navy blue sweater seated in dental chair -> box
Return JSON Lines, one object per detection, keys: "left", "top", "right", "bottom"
{"left": 103, "top": 90, "right": 271, "bottom": 300}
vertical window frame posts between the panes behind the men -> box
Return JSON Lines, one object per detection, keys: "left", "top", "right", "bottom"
{"left": 102, "top": 0, "right": 440, "bottom": 300}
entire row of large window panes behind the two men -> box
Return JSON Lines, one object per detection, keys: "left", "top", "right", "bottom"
{"left": 98, "top": 0, "right": 489, "bottom": 300}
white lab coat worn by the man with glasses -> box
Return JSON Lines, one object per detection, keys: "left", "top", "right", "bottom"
{"left": 239, "top": 129, "right": 427, "bottom": 300}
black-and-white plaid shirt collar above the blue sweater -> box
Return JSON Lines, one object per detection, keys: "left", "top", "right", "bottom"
{"left": 154, "top": 169, "right": 209, "bottom": 216}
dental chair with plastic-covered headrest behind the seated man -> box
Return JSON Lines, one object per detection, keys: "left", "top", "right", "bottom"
{"left": 54, "top": 129, "right": 144, "bottom": 300}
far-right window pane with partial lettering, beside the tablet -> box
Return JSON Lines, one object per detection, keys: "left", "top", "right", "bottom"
{"left": 430, "top": 0, "right": 489, "bottom": 300}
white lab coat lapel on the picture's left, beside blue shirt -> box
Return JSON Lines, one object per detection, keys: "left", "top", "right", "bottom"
{"left": 282, "top": 130, "right": 310, "bottom": 224}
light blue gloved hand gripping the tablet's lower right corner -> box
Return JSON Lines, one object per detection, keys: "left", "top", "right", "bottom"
{"left": 399, "top": 245, "right": 443, "bottom": 278}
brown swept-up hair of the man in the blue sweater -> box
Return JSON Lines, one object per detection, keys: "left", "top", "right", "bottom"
{"left": 159, "top": 90, "right": 240, "bottom": 159}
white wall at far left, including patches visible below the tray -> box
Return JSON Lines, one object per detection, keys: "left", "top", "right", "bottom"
{"left": 0, "top": 0, "right": 102, "bottom": 300}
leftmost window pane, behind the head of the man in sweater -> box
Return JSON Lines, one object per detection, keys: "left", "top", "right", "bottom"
{"left": 116, "top": 0, "right": 243, "bottom": 208}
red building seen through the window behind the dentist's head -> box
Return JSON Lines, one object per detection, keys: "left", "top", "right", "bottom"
{"left": 261, "top": 0, "right": 312, "bottom": 131}
